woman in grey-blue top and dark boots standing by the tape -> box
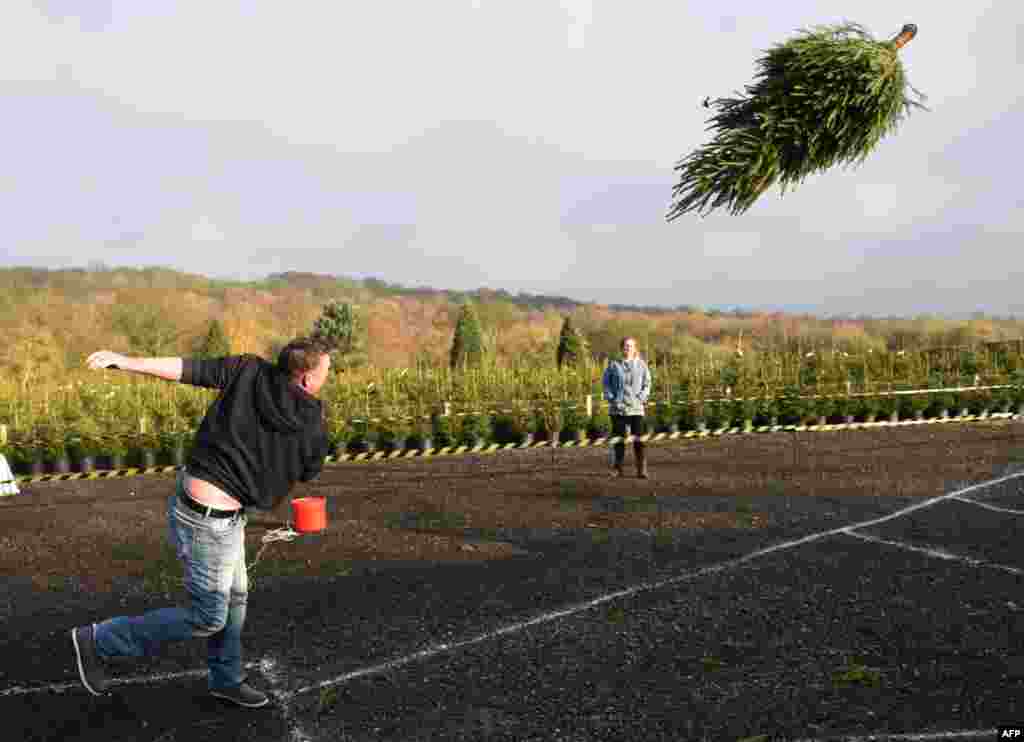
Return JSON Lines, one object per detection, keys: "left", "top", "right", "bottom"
{"left": 602, "top": 338, "right": 650, "bottom": 479}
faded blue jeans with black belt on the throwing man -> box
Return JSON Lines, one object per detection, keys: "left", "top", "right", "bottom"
{"left": 96, "top": 471, "right": 249, "bottom": 689}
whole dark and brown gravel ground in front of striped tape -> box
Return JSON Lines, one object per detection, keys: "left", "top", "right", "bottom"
{"left": 0, "top": 421, "right": 1024, "bottom": 742}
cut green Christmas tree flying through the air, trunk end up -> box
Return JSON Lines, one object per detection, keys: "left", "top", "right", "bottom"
{"left": 667, "top": 24, "right": 925, "bottom": 221}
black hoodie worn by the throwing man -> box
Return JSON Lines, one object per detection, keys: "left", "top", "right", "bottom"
{"left": 181, "top": 355, "right": 328, "bottom": 510}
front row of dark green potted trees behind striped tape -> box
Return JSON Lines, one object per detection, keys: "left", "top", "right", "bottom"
{"left": 8, "top": 386, "right": 1024, "bottom": 475}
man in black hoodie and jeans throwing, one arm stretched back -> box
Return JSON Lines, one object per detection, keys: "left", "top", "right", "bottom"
{"left": 71, "top": 338, "right": 331, "bottom": 708}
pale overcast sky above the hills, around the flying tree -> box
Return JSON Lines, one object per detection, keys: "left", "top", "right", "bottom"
{"left": 0, "top": 0, "right": 1024, "bottom": 315}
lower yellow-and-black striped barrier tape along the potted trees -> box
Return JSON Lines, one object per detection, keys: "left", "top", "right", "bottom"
{"left": 0, "top": 412, "right": 1024, "bottom": 484}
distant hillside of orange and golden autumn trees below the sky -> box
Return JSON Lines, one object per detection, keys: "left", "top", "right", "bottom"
{"left": 0, "top": 264, "right": 1024, "bottom": 372}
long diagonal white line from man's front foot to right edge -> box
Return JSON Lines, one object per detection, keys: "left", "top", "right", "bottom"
{"left": 288, "top": 472, "right": 1024, "bottom": 698}
